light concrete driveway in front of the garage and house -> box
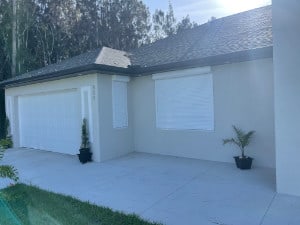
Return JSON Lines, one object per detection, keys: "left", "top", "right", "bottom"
{"left": 2, "top": 149, "right": 300, "bottom": 225}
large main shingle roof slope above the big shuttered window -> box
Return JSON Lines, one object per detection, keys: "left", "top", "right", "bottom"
{"left": 130, "top": 6, "right": 272, "bottom": 67}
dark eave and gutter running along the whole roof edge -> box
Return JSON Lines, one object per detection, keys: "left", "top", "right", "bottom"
{"left": 0, "top": 46, "right": 273, "bottom": 88}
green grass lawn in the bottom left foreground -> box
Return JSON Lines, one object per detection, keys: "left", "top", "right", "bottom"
{"left": 0, "top": 184, "right": 162, "bottom": 225}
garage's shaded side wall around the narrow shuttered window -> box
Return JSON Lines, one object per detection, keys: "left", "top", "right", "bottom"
{"left": 97, "top": 74, "right": 133, "bottom": 161}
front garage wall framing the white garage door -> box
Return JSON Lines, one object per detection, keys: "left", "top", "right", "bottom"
{"left": 5, "top": 74, "right": 100, "bottom": 161}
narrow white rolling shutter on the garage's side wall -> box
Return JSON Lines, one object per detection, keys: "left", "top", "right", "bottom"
{"left": 112, "top": 76, "right": 129, "bottom": 128}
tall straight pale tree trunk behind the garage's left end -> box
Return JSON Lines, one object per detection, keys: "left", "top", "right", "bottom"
{"left": 11, "top": 0, "right": 17, "bottom": 77}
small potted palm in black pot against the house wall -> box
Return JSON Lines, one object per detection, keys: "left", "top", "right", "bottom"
{"left": 223, "top": 126, "right": 255, "bottom": 170}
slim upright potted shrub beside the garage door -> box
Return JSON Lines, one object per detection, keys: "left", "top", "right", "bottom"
{"left": 78, "top": 119, "right": 92, "bottom": 163}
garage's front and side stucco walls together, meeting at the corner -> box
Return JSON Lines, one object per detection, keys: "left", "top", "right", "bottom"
{"left": 5, "top": 74, "right": 133, "bottom": 162}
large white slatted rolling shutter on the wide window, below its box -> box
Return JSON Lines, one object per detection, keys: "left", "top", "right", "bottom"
{"left": 154, "top": 67, "right": 214, "bottom": 131}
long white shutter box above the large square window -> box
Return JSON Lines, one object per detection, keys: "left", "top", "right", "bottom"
{"left": 152, "top": 66, "right": 211, "bottom": 80}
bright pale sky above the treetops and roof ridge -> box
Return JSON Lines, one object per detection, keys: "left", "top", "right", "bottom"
{"left": 142, "top": 0, "right": 272, "bottom": 24}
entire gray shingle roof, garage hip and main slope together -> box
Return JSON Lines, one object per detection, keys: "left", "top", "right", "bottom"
{"left": 0, "top": 6, "right": 273, "bottom": 86}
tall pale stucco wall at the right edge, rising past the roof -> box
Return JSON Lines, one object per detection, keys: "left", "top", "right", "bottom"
{"left": 273, "top": 0, "right": 300, "bottom": 196}
